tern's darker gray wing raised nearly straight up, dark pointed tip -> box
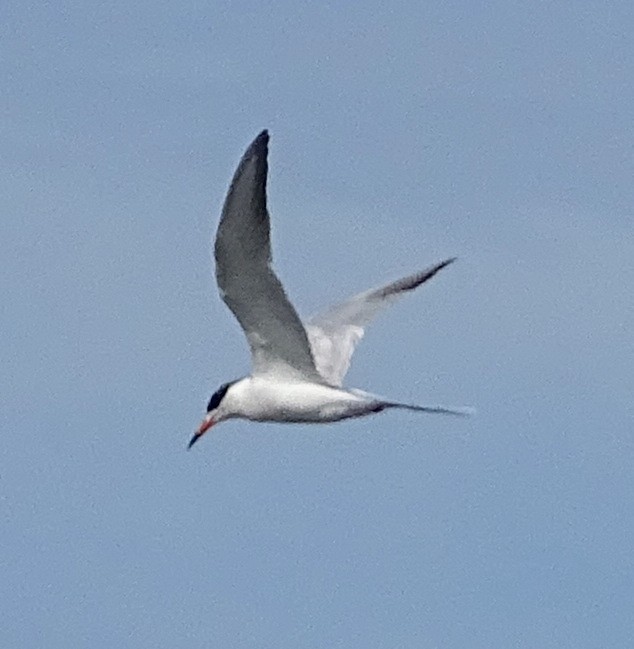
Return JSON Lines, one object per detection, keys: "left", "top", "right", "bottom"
{"left": 215, "top": 131, "right": 322, "bottom": 381}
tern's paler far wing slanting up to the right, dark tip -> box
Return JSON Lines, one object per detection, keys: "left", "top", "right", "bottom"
{"left": 306, "top": 257, "right": 455, "bottom": 385}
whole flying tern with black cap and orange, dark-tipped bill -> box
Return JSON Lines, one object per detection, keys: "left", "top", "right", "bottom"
{"left": 189, "top": 130, "right": 469, "bottom": 448}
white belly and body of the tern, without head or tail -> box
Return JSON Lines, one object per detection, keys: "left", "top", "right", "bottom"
{"left": 240, "top": 378, "right": 375, "bottom": 423}
